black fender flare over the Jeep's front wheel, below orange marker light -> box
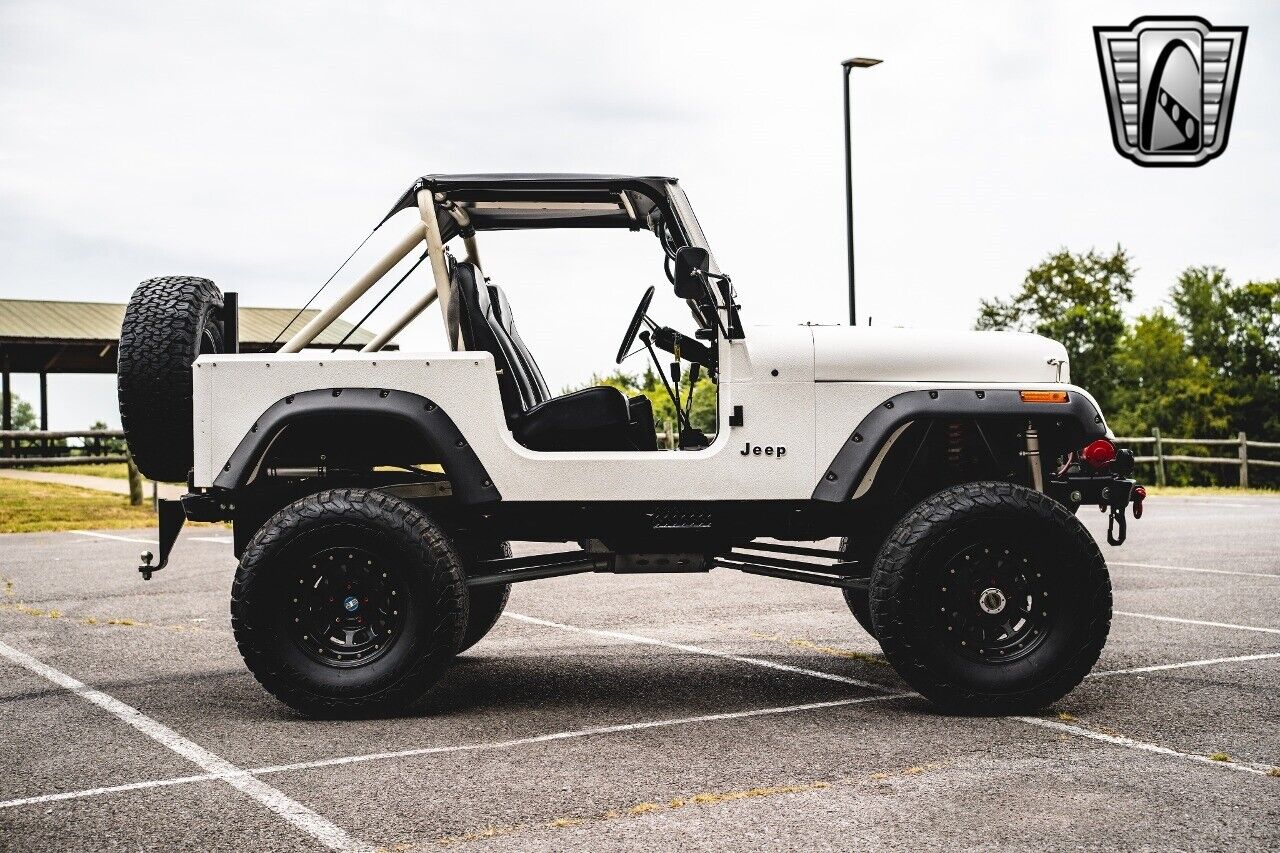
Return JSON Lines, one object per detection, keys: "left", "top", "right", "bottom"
{"left": 813, "top": 388, "right": 1107, "bottom": 503}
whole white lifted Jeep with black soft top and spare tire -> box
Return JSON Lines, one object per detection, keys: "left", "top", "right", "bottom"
{"left": 119, "top": 174, "right": 1144, "bottom": 715}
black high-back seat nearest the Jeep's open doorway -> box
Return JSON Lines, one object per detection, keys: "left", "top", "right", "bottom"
{"left": 448, "top": 261, "right": 655, "bottom": 451}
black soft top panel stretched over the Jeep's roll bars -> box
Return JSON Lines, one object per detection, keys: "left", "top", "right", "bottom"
{"left": 383, "top": 174, "right": 676, "bottom": 233}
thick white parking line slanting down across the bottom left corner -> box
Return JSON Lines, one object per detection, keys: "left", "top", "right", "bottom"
{"left": 0, "top": 642, "right": 371, "bottom": 850}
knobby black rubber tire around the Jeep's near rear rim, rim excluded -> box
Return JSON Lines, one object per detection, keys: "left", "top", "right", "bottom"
{"left": 232, "top": 489, "right": 467, "bottom": 717}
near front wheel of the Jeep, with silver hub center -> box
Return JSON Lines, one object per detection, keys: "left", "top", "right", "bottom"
{"left": 870, "top": 483, "right": 1111, "bottom": 713}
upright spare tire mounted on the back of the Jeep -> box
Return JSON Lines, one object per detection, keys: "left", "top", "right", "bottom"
{"left": 116, "top": 275, "right": 225, "bottom": 482}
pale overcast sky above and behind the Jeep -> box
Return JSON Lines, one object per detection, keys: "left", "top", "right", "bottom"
{"left": 0, "top": 0, "right": 1280, "bottom": 429}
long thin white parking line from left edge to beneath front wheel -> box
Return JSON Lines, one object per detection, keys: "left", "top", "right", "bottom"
{"left": 0, "top": 693, "right": 914, "bottom": 809}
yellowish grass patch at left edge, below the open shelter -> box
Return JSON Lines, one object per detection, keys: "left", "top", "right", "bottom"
{"left": 0, "top": 479, "right": 156, "bottom": 533}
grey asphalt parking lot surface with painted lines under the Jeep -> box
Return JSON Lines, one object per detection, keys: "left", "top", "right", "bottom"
{"left": 0, "top": 496, "right": 1280, "bottom": 850}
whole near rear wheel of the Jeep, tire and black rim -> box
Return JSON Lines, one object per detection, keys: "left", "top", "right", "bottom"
{"left": 232, "top": 489, "right": 467, "bottom": 716}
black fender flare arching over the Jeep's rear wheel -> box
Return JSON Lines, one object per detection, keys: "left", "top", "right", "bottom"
{"left": 214, "top": 388, "right": 502, "bottom": 505}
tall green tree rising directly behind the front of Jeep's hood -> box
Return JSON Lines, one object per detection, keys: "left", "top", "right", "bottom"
{"left": 975, "top": 246, "right": 1134, "bottom": 407}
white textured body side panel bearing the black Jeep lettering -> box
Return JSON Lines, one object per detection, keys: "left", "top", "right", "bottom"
{"left": 193, "top": 338, "right": 824, "bottom": 502}
